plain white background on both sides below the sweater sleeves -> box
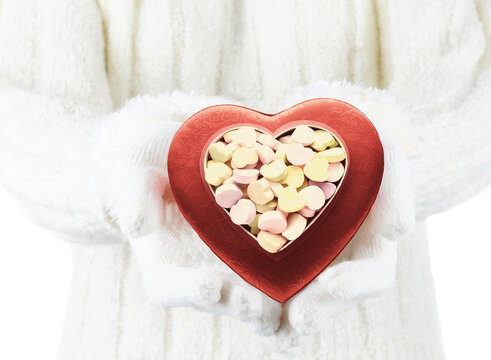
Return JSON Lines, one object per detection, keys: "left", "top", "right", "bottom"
{"left": 0, "top": 187, "right": 491, "bottom": 360}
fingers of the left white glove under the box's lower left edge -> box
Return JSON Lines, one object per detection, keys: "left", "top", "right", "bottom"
{"left": 130, "top": 232, "right": 281, "bottom": 335}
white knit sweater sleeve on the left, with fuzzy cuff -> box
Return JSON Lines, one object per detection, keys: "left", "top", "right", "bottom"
{"left": 0, "top": 0, "right": 227, "bottom": 243}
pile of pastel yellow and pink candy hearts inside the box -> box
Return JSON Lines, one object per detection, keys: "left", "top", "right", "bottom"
{"left": 203, "top": 125, "right": 346, "bottom": 253}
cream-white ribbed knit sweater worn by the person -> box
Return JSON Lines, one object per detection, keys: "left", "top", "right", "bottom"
{"left": 0, "top": 0, "right": 491, "bottom": 360}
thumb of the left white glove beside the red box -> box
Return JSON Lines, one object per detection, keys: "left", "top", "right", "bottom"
{"left": 108, "top": 121, "right": 180, "bottom": 238}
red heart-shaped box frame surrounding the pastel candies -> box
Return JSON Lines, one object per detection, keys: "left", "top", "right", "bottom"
{"left": 168, "top": 98, "right": 384, "bottom": 302}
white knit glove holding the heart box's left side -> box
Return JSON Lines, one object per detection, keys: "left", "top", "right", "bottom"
{"left": 111, "top": 92, "right": 281, "bottom": 335}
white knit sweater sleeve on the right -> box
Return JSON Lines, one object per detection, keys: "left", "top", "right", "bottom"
{"left": 379, "top": 1, "right": 491, "bottom": 217}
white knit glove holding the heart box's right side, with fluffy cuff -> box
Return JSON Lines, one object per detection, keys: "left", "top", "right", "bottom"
{"left": 268, "top": 82, "right": 415, "bottom": 355}
